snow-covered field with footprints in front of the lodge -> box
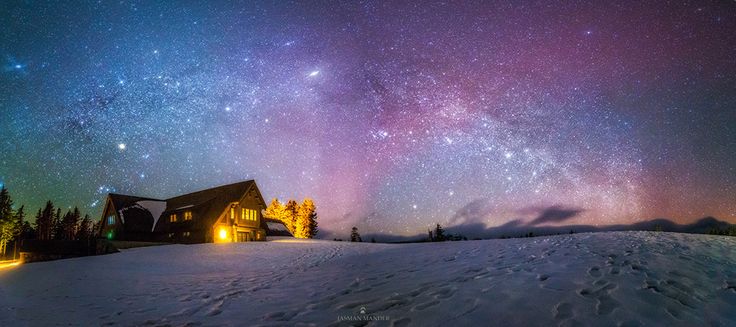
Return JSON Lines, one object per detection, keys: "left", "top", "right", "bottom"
{"left": 0, "top": 232, "right": 736, "bottom": 326}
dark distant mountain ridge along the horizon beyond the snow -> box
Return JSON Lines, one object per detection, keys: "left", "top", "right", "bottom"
{"left": 363, "top": 216, "right": 736, "bottom": 242}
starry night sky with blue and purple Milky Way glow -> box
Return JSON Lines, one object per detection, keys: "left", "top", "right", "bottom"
{"left": 0, "top": 1, "right": 736, "bottom": 235}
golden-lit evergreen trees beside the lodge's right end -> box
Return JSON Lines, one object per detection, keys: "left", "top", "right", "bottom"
{"left": 265, "top": 198, "right": 317, "bottom": 238}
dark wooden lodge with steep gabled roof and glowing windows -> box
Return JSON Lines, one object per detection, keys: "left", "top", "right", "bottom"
{"left": 98, "top": 180, "right": 291, "bottom": 243}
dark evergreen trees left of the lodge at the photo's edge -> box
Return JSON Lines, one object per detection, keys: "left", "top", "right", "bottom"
{"left": 0, "top": 187, "right": 99, "bottom": 256}
